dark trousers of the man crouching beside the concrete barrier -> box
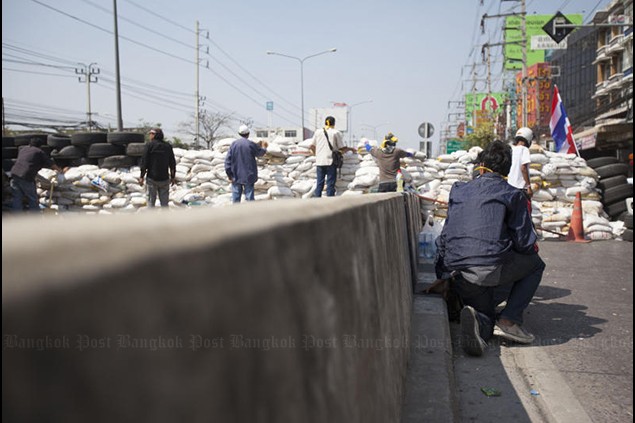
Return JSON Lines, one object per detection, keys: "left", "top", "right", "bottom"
{"left": 454, "top": 254, "right": 545, "bottom": 341}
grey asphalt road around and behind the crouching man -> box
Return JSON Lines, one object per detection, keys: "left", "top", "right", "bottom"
{"left": 450, "top": 241, "right": 633, "bottom": 423}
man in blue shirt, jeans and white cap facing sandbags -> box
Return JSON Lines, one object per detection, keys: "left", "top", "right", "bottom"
{"left": 225, "top": 125, "right": 269, "bottom": 203}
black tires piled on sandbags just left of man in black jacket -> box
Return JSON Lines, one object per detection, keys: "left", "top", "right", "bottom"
{"left": 47, "top": 132, "right": 145, "bottom": 168}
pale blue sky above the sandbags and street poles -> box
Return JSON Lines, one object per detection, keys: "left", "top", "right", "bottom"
{"left": 2, "top": 0, "right": 608, "bottom": 152}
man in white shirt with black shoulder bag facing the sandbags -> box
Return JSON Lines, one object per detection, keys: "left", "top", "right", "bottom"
{"left": 311, "top": 116, "right": 347, "bottom": 197}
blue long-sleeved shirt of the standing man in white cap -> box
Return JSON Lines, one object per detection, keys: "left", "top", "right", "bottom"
{"left": 225, "top": 137, "right": 267, "bottom": 185}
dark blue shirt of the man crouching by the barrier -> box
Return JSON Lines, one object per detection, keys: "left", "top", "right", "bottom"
{"left": 437, "top": 173, "right": 537, "bottom": 270}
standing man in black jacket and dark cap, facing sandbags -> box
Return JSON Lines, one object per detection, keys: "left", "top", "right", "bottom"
{"left": 139, "top": 128, "right": 176, "bottom": 207}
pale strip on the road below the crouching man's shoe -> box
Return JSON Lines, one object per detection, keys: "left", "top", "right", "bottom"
{"left": 500, "top": 346, "right": 592, "bottom": 423}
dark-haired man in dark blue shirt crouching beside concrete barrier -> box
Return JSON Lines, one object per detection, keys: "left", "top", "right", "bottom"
{"left": 436, "top": 141, "right": 545, "bottom": 356}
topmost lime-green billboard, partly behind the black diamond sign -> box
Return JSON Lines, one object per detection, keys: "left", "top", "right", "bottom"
{"left": 503, "top": 14, "right": 582, "bottom": 70}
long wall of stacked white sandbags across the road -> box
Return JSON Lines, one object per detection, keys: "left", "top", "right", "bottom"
{"left": 31, "top": 137, "right": 615, "bottom": 239}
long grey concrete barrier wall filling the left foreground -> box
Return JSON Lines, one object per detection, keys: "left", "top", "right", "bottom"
{"left": 2, "top": 194, "right": 419, "bottom": 423}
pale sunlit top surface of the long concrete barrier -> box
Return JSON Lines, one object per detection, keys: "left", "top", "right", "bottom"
{"left": 2, "top": 194, "right": 404, "bottom": 303}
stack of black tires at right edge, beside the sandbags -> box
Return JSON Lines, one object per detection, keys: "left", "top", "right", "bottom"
{"left": 587, "top": 157, "right": 633, "bottom": 227}
